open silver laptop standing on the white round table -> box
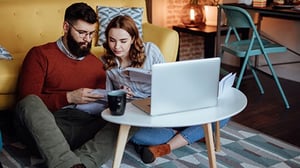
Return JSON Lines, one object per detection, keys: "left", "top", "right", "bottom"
{"left": 132, "top": 57, "right": 220, "bottom": 116}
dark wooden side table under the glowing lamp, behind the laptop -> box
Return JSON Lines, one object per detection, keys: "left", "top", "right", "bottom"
{"left": 172, "top": 25, "right": 249, "bottom": 61}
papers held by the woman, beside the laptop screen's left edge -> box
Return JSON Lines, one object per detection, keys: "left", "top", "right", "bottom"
{"left": 123, "top": 67, "right": 152, "bottom": 83}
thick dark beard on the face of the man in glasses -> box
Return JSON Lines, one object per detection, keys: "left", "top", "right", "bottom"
{"left": 67, "top": 31, "right": 92, "bottom": 58}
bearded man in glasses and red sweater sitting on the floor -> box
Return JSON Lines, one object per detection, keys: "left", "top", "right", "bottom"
{"left": 14, "top": 3, "right": 136, "bottom": 168}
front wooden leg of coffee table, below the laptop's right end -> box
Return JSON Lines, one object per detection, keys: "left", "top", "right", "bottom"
{"left": 203, "top": 123, "right": 217, "bottom": 168}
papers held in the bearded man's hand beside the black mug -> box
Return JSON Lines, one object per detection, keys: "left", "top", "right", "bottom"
{"left": 63, "top": 89, "right": 108, "bottom": 115}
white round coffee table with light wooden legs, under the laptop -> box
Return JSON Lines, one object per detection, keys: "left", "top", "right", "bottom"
{"left": 101, "top": 88, "right": 247, "bottom": 168}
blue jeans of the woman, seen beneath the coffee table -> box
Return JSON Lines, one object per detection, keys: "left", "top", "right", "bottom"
{"left": 131, "top": 118, "right": 229, "bottom": 146}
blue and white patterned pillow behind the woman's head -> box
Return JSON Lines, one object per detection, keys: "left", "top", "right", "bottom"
{"left": 97, "top": 6, "right": 143, "bottom": 46}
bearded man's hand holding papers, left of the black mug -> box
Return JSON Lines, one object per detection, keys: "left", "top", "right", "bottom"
{"left": 67, "top": 88, "right": 104, "bottom": 104}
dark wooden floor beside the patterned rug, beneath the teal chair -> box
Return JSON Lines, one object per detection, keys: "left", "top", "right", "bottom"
{"left": 223, "top": 65, "right": 300, "bottom": 147}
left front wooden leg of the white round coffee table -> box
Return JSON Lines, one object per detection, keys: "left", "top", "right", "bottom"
{"left": 113, "top": 125, "right": 131, "bottom": 168}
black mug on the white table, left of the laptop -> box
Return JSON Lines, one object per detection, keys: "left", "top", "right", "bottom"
{"left": 107, "top": 90, "right": 126, "bottom": 115}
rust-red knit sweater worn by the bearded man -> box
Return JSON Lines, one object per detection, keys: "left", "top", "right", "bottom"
{"left": 18, "top": 42, "right": 105, "bottom": 112}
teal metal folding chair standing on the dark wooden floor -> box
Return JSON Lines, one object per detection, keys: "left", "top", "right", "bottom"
{"left": 219, "top": 5, "right": 290, "bottom": 109}
